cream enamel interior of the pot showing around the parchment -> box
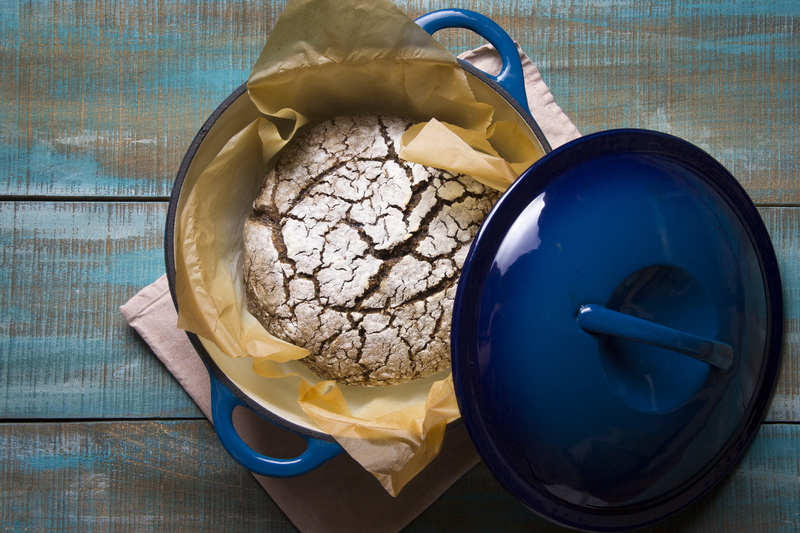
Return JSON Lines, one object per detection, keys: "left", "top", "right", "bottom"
{"left": 165, "top": 67, "right": 550, "bottom": 439}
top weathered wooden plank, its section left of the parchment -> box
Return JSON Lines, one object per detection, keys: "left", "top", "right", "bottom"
{"left": 0, "top": 0, "right": 285, "bottom": 196}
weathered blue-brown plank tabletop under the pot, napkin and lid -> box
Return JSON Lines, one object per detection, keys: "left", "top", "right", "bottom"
{"left": 0, "top": 0, "right": 800, "bottom": 532}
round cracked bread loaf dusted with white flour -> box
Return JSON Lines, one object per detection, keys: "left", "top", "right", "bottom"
{"left": 244, "top": 115, "right": 500, "bottom": 386}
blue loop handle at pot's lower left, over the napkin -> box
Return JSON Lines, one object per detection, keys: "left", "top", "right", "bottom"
{"left": 208, "top": 372, "right": 343, "bottom": 477}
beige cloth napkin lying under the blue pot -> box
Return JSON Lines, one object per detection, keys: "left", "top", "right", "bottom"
{"left": 120, "top": 45, "right": 580, "bottom": 533}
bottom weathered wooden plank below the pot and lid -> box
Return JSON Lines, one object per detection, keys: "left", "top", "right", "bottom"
{"left": 0, "top": 421, "right": 800, "bottom": 533}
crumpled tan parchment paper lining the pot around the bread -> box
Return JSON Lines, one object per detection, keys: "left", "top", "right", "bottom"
{"left": 176, "top": 0, "right": 538, "bottom": 495}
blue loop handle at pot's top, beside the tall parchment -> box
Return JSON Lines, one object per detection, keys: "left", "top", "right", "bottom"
{"left": 414, "top": 9, "right": 531, "bottom": 115}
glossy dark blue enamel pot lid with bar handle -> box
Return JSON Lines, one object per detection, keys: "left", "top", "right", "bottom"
{"left": 451, "top": 130, "right": 783, "bottom": 531}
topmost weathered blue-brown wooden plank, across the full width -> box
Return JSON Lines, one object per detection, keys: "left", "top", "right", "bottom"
{"left": 0, "top": 0, "right": 800, "bottom": 204}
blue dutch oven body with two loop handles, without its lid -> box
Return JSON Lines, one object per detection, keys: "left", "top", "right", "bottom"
{"left": 165, "top": 11, "right": 550, "bottom": 477}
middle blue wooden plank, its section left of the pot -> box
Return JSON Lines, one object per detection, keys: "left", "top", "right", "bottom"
{"left": 0, "top": 202, "right": 201, "bottom": 418}
